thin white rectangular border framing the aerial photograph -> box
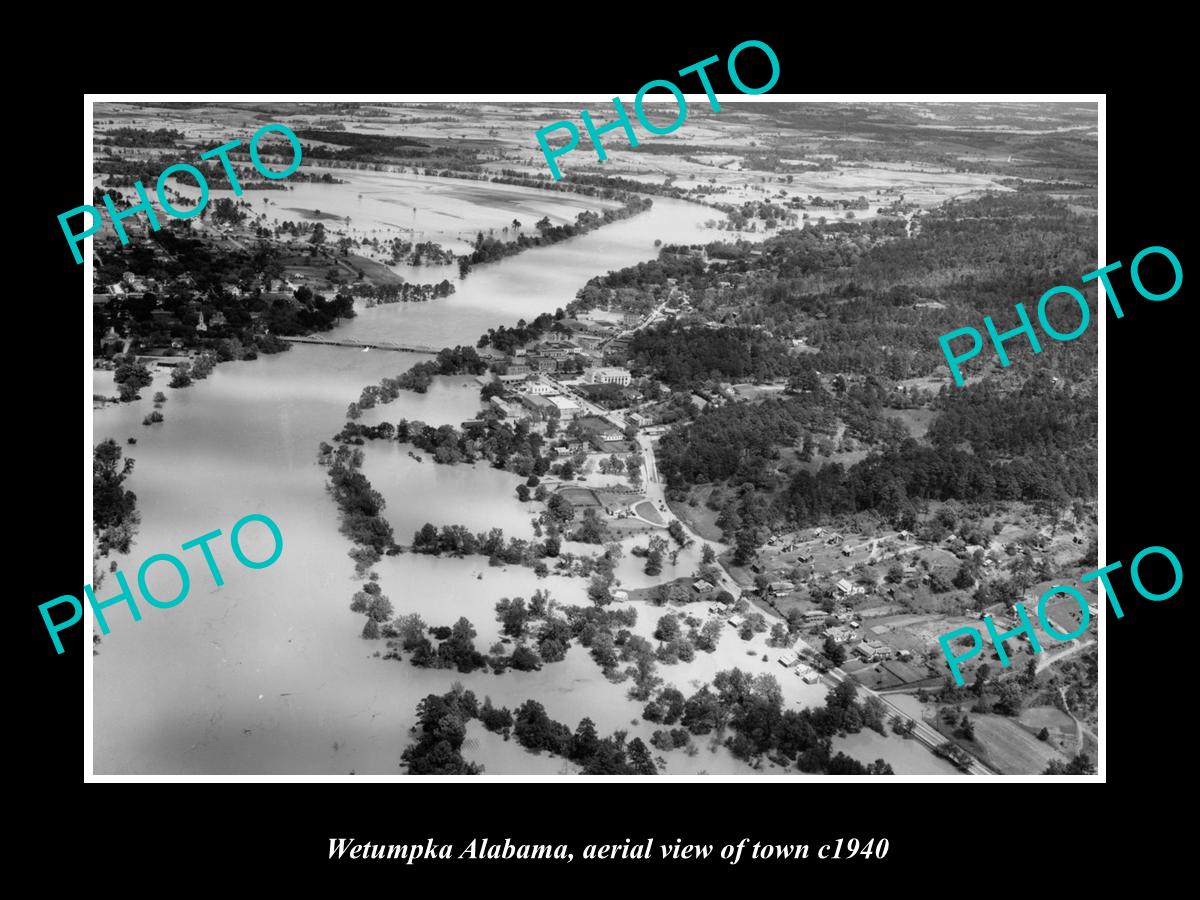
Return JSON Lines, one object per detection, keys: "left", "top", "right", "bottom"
{"left": 82, "top": 92, "right": 1108, "bottom": 784}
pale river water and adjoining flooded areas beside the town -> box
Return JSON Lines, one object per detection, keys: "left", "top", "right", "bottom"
{"left": 92, "top": 198, "right": 942, "bottom": 774}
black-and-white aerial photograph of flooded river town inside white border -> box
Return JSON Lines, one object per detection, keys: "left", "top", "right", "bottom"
{"left": 91, "top": 98, "right": 1102, "bottom": 778}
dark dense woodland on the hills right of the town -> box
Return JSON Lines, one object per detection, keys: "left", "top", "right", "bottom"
{"left": 628, "top": 193, "right": 1098, "bottom": 558}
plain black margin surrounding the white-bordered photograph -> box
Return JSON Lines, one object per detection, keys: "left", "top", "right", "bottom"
{"left": 14, "top": 21, "right": 1196, "bottom": 893}
